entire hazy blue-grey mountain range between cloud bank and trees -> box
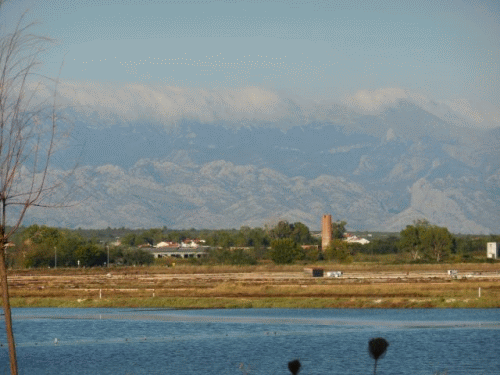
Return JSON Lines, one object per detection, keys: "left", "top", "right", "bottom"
{"left": 21, "top": 99, "right": 500, "bottom": 234}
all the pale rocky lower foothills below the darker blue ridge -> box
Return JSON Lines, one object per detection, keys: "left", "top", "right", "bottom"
{"left": 22, "top": 154, "right": 500, "bottom": 233}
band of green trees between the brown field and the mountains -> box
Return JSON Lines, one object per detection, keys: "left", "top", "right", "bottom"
{"left": 7, "top": 220, "right": 500, "bottom": 268}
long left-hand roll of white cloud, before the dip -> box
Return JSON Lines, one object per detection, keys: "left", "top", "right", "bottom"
{"left": 54, "top": 82, "right": 287, "bottom": 125}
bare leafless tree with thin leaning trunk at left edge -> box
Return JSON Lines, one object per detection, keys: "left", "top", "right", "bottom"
{"left": 0, "top": 9, "right": 77, "bottom": 375}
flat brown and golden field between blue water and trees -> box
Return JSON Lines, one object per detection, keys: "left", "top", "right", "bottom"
{"left": 3, "top": 263, "right": 500, "bottom": 308}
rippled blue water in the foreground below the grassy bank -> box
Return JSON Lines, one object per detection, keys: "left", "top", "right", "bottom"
{"left": 0, "top": 309, "right": 500, "bottom": 375}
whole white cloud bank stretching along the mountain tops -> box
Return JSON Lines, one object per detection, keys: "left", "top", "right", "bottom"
{"left": 36, "top": 82, "right": 500, "bottom": 128}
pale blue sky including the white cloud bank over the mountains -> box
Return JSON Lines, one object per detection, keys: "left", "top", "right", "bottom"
{"left": 0, "top": 0, "right": 500, "bottom": 127}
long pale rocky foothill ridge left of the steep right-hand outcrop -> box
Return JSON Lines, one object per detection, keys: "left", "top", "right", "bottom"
{"left": 21, "top": 159, "right": 384, "bottom": 228}
